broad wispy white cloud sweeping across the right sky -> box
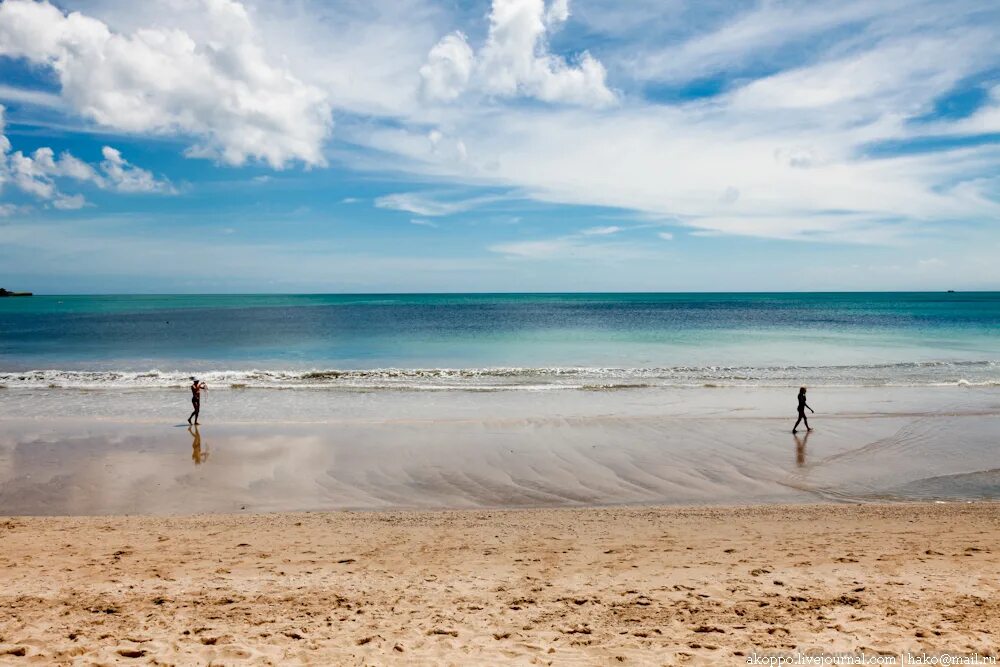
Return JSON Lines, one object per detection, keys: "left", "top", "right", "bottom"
{"left": 362, "top": 0, "right": 1000, "bottom": 243}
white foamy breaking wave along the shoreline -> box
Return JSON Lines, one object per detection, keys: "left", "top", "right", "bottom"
{"left": 0, "top": 361, "right": 1000, "bottom": 391}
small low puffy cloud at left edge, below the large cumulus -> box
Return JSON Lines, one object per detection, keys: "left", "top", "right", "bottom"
{"left": 0, "top": 105, "right": 174, "bottom": 210}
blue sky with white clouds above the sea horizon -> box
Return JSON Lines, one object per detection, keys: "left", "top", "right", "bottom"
{"left": 0, "top": 0, "right": 1000, "bottom": 294}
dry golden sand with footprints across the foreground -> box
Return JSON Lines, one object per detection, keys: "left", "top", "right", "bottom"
{"left": 0, "top": 503, "right": 1000, "bottom": 665}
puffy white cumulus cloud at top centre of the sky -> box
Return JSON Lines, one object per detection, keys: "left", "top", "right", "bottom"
{"left": 420, "top": 0, "right": 616, "bottom": 107}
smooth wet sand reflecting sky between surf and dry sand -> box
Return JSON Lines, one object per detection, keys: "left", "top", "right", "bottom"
{"left": 0, "top": 387, "right": 1000, "bottom": 515}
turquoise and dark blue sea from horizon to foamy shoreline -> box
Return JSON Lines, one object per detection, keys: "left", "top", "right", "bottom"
{"left": 0, "top": 292, "right": 1000, "bottom": 388}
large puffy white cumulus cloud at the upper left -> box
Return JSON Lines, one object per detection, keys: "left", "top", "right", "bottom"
{"left": 0, "top": 0, "right": 331, "bottom": 170}
